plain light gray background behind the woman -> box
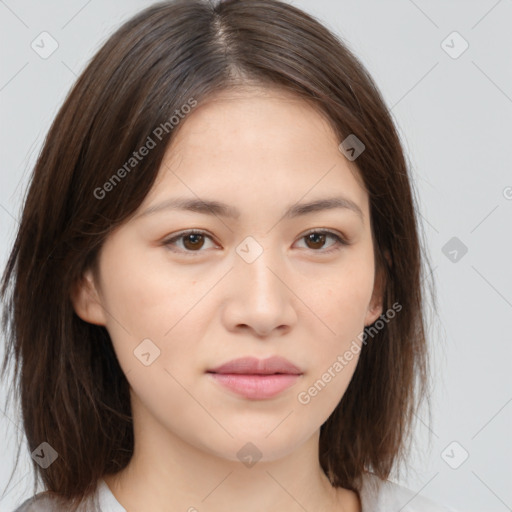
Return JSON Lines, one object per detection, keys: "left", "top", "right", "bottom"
{"left": 0, "top": 0, "right": 512, "bottom": 512}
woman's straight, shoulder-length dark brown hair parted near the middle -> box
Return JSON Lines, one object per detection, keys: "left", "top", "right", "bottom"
{"left": 1, "top": 0, "right": 434, "bottom": 503}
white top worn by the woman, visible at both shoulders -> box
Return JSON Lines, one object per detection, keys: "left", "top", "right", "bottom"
{"left": 14, "top": 474, "right": 456, "bottom": 512}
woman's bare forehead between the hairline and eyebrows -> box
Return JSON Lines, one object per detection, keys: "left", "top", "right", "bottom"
{"left": 145, "top": 87, "right": 368, "bottom": 217}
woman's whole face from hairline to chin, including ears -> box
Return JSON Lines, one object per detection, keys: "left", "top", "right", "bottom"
{"left": 74, "top": 89, "right": 382, "bottom": 461}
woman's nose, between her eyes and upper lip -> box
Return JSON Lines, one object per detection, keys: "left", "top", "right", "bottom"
{"left": 222, "top": 242, "right": 297, "bottom": 337}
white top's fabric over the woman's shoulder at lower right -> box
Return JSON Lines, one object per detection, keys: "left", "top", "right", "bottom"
{"left": 360, "top": 473, "right": 456, "bottom": 512}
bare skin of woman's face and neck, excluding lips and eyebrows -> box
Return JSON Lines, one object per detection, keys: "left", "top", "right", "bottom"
{"left": 73, "top": 87, "right": 382, "bottom": 512}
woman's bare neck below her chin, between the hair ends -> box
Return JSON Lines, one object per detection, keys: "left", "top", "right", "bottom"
{"left": 104, "top": 402, "right": 360, "bottom": 512}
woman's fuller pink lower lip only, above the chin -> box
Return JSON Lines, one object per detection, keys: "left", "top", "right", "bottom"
{"left": 211, "top": 373, "right": 300, "bottom": 400}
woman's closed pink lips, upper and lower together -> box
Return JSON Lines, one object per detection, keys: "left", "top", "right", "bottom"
{"left": 208, "top": 357, "right": 302, "bottom": 400}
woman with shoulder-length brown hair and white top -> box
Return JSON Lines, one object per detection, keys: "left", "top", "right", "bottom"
{"left": 3, "top": 0, "right": 456, "bottom": 512}
